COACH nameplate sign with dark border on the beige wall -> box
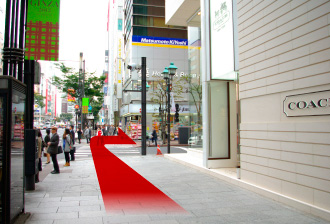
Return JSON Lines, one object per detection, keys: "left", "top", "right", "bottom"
{"left": 283, "top": 90, "right": 330, "bottom": 117}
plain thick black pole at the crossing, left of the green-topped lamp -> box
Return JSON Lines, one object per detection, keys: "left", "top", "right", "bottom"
{"left": 141, "top": 57, "right": 147, "bottom": 156}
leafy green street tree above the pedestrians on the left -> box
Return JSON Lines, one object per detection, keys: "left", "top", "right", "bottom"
{"left": 53, "top": 63, "right": 106, "bottom": 117}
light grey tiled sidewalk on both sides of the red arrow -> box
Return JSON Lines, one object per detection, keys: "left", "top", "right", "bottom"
{"left": 21, "top": 145, "right": 328, "bottom": 224}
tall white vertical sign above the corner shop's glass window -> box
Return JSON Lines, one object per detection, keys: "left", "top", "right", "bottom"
{"left": 210, "top": 0, "right": 236, "bottom": 80}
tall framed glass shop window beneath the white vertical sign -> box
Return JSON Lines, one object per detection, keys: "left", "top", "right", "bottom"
{"left": 207, "top": 81, "right": 237, "bottom": 168}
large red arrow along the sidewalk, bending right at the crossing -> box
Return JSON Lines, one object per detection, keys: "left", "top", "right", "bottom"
{"left": 90, "top": 129, "right": 187, "bottom": 214}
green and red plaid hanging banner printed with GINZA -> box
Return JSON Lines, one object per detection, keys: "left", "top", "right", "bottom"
{"left": 25, "top": 0, "right": 60, "bottom": 61}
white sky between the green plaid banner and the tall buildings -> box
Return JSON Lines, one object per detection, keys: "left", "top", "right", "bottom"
{"left": 57, "top": 0, "right": 108, "bottom": 75}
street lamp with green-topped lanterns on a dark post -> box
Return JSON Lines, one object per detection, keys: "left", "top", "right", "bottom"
{"left": 162, "top": 62, "right": 178, "bottom": 154}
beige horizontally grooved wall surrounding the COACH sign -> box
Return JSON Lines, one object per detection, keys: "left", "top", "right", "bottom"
{"left": 238, "top": 0, "right": 330, "bottom": 210}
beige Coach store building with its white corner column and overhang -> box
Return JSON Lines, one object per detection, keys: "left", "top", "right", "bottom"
{"left": 166, "top": 0, "right": 330, "bottom": 220}
